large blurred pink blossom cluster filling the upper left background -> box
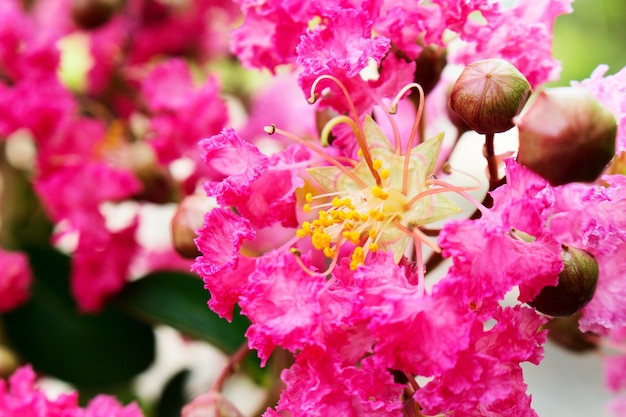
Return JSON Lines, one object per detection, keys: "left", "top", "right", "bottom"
{"left": 0, "top": 0, "right": 238, "bottom": 312}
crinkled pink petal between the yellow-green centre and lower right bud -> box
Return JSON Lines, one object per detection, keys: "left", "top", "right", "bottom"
{"left": 439, "top": 159, "right": 563, "bottom": 310}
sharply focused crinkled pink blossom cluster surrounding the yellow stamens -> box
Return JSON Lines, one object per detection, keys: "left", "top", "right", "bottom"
{"left": 186, "top": 1, "right": 626, "bottom": 416}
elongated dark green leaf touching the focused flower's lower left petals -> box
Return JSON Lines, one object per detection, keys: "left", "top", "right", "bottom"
{"left": 115, "top": 272, "right": 250, "bottom": 354}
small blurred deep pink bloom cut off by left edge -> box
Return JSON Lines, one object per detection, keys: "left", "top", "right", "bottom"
{"left": 0, "top": 249, "right": 33, "bottom": 312}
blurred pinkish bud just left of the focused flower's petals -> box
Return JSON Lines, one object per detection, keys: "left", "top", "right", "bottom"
{"left": 171, "top": 194, "right": 216, "bottom": 259}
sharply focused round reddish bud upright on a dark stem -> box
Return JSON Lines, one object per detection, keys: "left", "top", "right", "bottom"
{"left": 448, "top": 59, "right": 532, "bottom": 134}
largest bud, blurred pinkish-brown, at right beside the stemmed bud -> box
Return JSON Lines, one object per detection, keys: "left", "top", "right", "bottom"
{"left": 515, "top": 87, "right": 617, "bottom": 186}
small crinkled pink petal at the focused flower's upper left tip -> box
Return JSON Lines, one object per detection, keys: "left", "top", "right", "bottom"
{"left": 199, "top": 128, "right": 269, "bottom": 196}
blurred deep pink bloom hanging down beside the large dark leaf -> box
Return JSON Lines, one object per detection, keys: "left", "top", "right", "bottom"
{"left": 35, "top": 162, "right": 141, "bottom": 312}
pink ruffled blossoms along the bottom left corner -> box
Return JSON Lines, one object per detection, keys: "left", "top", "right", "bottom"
{"left": 0, "top": 365, "right": 143, "bottom": 417}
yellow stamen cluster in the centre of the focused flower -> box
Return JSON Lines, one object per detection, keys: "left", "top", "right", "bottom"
{"left": 296, "top": 159, "right": 397, "bottom": 270}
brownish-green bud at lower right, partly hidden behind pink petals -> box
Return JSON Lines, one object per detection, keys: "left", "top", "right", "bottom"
{"left": 528, "top": 245, "right": 599, "bottom": 317}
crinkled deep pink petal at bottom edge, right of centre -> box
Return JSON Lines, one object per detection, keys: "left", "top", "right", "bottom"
{"left": 415, "top": 306, "right": 546, "bottom": 416}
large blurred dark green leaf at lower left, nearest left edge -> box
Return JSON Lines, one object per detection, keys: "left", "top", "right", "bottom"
{"left": 3, "top": 248, "right": 155, "bottom": 387}
